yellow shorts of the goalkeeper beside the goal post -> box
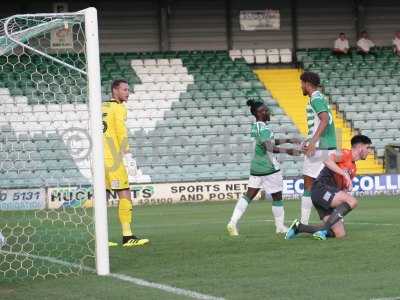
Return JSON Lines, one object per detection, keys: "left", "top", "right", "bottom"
{"left": 104, "top": 159, "right": 129, "bottom": 190}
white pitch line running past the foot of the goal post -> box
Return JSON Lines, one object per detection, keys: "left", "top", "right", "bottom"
{"left": 0, "top": 250, "right": 225, "bottom": 300}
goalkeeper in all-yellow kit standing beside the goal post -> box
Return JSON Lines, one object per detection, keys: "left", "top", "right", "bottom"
{"left": 102, "top": 80, "right": 149, "bottom": 247}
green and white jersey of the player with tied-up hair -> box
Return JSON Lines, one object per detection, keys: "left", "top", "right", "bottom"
{"left": 250, "top": 122, "right": 279, "bottom": 176}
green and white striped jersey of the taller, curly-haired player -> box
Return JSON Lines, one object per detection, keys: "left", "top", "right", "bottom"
{"left": 306, "top": 91, "right": 336, "bottom": 149}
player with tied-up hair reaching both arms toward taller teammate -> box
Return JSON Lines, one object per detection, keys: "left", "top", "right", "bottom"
{"left": 227, "top": 100, "right": 301, "bottom": 236}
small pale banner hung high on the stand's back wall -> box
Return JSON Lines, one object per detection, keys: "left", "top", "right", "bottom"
{"left": 239, "top": 9, "right": 281, "bottom": 31}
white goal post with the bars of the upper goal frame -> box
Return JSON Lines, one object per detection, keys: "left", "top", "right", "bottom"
{"left": 0, "top": 7, "right": 110, "bottom": 275}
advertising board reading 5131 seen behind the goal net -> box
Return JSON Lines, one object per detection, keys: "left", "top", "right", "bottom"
{"left": 0, "top": 189, "right": 46, "bottom": 210}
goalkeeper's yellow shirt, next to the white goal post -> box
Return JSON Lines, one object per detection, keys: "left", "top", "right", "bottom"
{"left": 102, "top": 99, "right": 129, "bottom": 160}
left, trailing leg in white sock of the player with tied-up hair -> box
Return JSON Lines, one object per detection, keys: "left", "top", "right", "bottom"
{"left": 226, "top": 176, "right": 261, "bottom": 236}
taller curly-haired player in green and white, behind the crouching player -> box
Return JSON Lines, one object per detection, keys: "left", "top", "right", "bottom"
{"left": 300, "top": 72, "right": 336, "bottom": 224}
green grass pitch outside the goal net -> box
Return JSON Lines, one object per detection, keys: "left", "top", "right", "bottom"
{"left": 0, "top": 196, "right": 400, "bottom": 300}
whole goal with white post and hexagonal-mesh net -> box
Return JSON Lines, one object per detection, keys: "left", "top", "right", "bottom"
{"left": 0, "top": 8, "right": 110, "bottom": 281}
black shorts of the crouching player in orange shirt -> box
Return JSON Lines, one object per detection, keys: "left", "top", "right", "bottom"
{"left": 311, "top": 181, "right": 340, "bottom": 220}
